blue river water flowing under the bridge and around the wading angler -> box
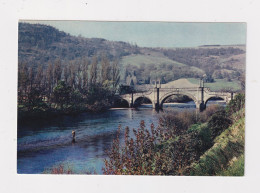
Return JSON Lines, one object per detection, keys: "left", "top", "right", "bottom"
{"left": 17, "top": 102, "right": 224, "bottom": 174}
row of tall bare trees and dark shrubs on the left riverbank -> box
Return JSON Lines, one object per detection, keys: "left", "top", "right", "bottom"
{"left": 18, "top": 55, "right": 120, "bottom": 117}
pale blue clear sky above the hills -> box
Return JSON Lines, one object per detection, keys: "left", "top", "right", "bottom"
{"left": 25, "top": 21, "right": 246, "bottom": 47}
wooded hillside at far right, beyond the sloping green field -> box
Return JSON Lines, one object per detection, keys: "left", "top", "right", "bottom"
{"left": 161, "top": 46, "right": 245, "bottom": 80}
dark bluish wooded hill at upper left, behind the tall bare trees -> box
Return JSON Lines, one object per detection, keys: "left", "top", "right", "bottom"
{"left": 18, "top": 23, "right": 139, "bottom": 66}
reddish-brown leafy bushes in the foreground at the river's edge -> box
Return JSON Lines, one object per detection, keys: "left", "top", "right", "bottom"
{"left": 103, "top": 112, "right": 209, "bottom": 175}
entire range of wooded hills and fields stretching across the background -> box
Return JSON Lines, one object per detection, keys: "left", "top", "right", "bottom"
{"left": 18, "top": 23, "right": 246, "bottom": 87}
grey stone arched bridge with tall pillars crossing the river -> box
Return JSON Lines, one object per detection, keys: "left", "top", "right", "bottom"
{"left": 120, "top": 83, "right": 233, "bottom": 111}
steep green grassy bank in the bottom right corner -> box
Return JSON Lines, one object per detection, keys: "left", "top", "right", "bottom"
{"left": 190, "top": 109, "right": 245, "bottom": 176}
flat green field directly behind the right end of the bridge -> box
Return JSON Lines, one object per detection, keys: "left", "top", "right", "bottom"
{"left": 188, "top": 78, "right": 241, "bottom": 91}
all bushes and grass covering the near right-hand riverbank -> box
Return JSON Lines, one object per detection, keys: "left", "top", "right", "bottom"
{"left": 103, "top": 94, "right": 244, "bottom": 175}
